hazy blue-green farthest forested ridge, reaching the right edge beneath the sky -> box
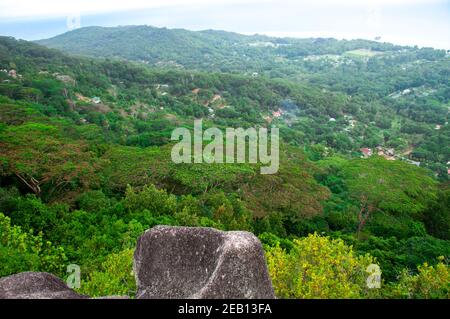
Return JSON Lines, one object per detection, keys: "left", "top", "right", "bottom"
{"left": 38, "top": 26, "right": 450, "bottom": 99}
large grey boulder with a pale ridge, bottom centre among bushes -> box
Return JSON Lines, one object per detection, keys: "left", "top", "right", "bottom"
{"left": 134, "top": 226, "right": 275, "bottom": 299}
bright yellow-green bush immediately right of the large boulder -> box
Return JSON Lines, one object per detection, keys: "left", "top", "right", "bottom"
{"left": 267, "top": 234, "right": 375, "bottom": 298}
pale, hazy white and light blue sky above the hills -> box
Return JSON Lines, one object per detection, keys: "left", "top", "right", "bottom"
{"left": 0, "top": 0, "right": 450, "bottom": 50}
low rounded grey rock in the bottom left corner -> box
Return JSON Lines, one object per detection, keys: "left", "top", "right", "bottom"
{"left": 0, "top": 272, "right": 88, "bottom": 299}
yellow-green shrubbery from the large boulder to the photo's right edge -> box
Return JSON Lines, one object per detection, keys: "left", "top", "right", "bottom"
{"left": 263, "top": 234, "right": 450, "bottom": 299}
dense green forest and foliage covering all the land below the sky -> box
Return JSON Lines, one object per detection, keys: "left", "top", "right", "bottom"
{"left": 0, "top": 27, "right": 450, "bottom": 298}
